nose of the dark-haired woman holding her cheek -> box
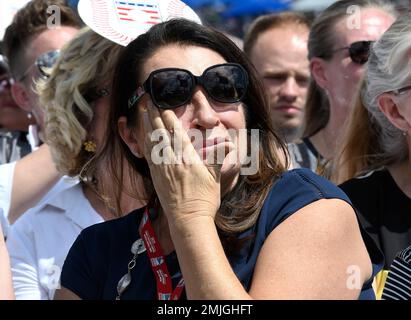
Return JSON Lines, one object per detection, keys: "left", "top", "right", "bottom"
{"left": 191, "top": 87, "right": 220, "bottom": 129}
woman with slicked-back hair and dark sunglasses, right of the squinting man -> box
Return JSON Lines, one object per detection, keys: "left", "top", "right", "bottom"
{"left": 290, "top": 0, "right": 396, "bottom": 177}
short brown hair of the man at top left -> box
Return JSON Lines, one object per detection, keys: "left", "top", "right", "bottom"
{"left": 3, "top": 0, "right": 81, "bottom": 77}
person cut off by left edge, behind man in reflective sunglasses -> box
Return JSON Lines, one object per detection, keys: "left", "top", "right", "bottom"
{"left": 0, "top": 51, "right": 34, "bottom": 164}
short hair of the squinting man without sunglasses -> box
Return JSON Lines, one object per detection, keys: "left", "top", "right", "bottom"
{"left": 244, "top": 12, "right": 310, "bottom": 56}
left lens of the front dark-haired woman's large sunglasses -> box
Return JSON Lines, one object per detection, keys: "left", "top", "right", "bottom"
{"left": 151, "top": 70, "right": 194, "bottom": 109}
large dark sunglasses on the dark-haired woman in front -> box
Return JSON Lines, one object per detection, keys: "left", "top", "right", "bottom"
{"left": 128, "top": 63, "right": 248, "bottom": 109}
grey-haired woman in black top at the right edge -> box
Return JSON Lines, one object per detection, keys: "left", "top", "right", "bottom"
{"left": 334, "top": 14, "right": 411, "bottom": 295}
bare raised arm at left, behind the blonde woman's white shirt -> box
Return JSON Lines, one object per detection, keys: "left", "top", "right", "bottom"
{"left": 8, "top": 144, "right": 61, "bottom": 224}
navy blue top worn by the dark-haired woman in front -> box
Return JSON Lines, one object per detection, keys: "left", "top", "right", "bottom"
{"left": 61, "top": 169, "right": 384, "bottom": 300}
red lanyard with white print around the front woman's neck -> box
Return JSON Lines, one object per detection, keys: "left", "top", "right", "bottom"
{"left": 139, "top": 207, "right": 184, "bottom": 300}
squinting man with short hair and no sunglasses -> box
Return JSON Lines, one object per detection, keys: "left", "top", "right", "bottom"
{"left": 244, "top": 12, "right": 310, "bottom": 142}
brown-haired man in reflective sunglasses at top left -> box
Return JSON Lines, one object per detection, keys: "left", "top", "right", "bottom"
{"left": 4, "top": 0, "right": 80, "bottom": 144}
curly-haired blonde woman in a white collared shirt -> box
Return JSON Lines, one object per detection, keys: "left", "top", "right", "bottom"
{"left": 7, "top": 29, "right": 146, "bottom": 299}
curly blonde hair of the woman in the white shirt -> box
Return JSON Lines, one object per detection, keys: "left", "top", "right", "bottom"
{"left": 37, "top": 28, "right": 122, "bottom": 178}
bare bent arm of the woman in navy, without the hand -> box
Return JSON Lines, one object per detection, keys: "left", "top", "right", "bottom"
{"left": 170, "top": 199, "right": 372, "bottom": 300}
